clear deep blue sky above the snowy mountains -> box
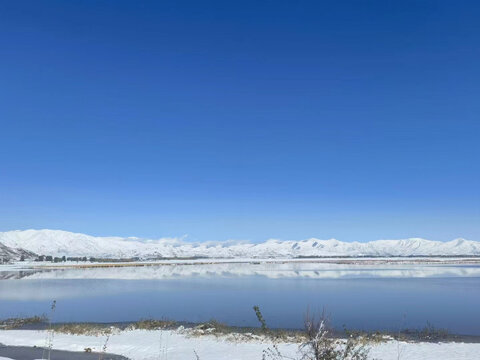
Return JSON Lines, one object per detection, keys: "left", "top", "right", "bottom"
{"left": 0, "top": 0, "right": 480, "bottom": 241}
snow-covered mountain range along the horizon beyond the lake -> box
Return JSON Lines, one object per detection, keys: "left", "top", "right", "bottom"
{"left": 0, "top": 230, "right": 480, "bottom": 259}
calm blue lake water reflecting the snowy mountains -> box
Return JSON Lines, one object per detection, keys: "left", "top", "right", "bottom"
{"left": 0, "top": 265, "right": 480, "bottom": 335}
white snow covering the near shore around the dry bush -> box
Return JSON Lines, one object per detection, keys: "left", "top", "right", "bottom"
{"left": 0, "top": 330, "right": 480, "bottom": 360}
